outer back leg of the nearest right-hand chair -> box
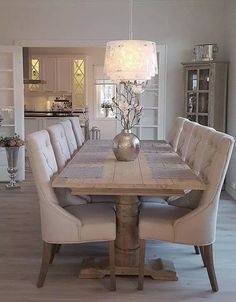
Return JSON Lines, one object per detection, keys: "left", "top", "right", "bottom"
{"left": 203, "top": 244, "right": 219, "bottom": 292}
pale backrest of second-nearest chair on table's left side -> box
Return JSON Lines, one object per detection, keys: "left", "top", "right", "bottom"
{"left": 47, "top": 124, "right": 71, "bottom": 170}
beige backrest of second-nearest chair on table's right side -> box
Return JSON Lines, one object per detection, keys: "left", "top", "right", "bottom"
{"left": 185, "top": 124, "right": 215, "bottom": 175}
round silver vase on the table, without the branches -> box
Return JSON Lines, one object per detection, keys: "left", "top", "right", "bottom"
{"left": 112, "top": 130, "right": 140, "bottom": 161}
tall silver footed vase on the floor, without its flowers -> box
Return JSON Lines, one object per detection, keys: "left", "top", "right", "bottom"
{"left": 5, "top": 147, "right": 20, "bottom": 189}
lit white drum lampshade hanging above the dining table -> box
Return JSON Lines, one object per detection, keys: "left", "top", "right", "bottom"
{"left": 104, "top": 40, "right": 158, "bottom": 82}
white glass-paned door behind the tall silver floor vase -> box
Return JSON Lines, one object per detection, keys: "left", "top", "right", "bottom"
{"left": 0, "top": 46, "right": 25, "bottom": 181}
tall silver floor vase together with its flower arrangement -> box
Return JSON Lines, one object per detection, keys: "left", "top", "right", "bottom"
{"left": 0, "top": 134, "right": 24, "bottom": 189}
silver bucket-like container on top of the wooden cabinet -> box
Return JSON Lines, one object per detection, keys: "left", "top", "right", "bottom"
{"left": 193, "top": 43, "right": 219, "bottom": 61}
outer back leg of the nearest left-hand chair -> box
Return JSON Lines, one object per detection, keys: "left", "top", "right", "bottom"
{"left": 37, "top": 241, "right": 53, "bottom": 288}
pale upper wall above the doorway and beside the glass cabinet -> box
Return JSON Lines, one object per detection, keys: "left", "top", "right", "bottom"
{"left": 0, "top": 0, "right": 225, "bottom": 137}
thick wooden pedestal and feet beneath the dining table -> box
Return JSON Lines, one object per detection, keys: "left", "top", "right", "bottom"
{"left": 79, "top": 196, "right": 177, "bottom": 281}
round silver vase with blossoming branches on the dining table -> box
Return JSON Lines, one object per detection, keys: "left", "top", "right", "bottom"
{"left": 111, "top": 82, "right": 144, "bottom": 161}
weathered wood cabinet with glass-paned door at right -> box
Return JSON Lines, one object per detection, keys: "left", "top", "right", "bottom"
{"left": 182, "top": 62, "right": 228, "bottom": 132}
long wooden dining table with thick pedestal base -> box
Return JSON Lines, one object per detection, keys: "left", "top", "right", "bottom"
{"left": 52, "top": 140, "right": 207, "bottom": 280}
